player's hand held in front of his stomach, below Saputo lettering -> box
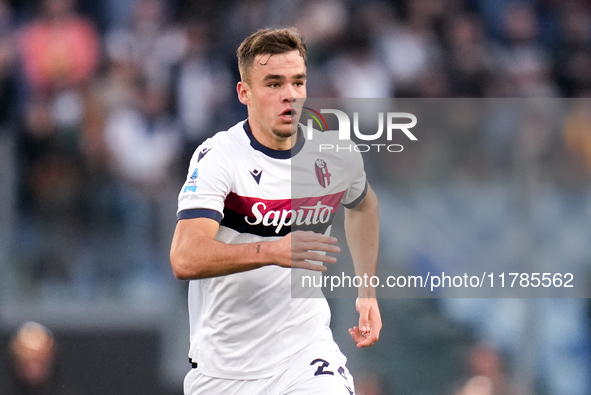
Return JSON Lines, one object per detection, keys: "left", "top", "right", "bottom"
{"left": 261, "top": 230, "right": 341, "bottom": 272}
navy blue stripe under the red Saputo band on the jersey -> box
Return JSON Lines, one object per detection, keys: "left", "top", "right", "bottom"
{"left": 220, "top": 209, "right": 334, "bottom": 237}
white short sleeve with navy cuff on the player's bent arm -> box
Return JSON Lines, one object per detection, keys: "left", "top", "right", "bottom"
{"left": 177, "top": 140, "right": 232, "bottom": 222}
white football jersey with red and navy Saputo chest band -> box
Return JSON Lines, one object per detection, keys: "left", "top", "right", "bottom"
{"left": 177, "top": 121, "right": 367, "bottom": 379}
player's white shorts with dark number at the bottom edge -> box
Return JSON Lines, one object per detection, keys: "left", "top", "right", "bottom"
{"left": 184, "top": 349, "right": 355, "bottom": 395}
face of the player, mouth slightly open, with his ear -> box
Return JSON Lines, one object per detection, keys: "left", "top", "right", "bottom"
{"left": 238, "top": 51, "right": 306, "bottom": 149}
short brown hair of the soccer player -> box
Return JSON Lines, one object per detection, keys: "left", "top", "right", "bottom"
{"left": 236, "top": 27, "right": 308, "bottom": 83}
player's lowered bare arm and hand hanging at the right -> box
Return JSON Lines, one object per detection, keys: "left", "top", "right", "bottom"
{"left": 345, "top": 185, "right": 382, "bottom": 347}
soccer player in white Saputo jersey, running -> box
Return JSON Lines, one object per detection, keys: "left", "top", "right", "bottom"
{"left": 170, "top": 29, "right": 382, "bottom": 395}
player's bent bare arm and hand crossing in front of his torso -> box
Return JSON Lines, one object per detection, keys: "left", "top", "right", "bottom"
{"left": 170, "top": 218, "right": 339, "bottom": 280}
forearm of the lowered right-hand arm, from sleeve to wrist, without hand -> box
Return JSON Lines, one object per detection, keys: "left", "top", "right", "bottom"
{"left": 345, "top": 187, "right": 380, "bottom": 297}
